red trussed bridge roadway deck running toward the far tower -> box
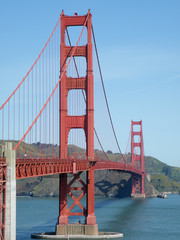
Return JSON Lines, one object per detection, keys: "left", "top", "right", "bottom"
{"left": 0, "top": 158, "right": 142, "bottom": 179}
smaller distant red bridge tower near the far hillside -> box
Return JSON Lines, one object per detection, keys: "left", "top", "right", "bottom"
{"left": 131, "top": 121, "right": 145, "bottom": 197}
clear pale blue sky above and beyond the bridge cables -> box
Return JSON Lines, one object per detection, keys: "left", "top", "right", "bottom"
{"left": 0, "top": 0, "right": 180, "bottom": 167}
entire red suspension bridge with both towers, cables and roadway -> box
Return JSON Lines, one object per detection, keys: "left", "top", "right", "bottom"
{"left": 0, "top": 11, "right": 145, "bottom": 240}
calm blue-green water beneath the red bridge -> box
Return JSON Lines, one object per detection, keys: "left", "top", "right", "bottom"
{"left": 17, "top": 195, "right": 180, "bottom": 240}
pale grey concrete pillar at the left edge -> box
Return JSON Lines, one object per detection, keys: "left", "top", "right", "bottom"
{"left": 4, "top": 142, "right": 16, "bottom": 240}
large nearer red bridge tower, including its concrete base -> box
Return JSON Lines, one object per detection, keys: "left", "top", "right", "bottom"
{"left": 56, "top": 11, "right": 98, "bottom": 235}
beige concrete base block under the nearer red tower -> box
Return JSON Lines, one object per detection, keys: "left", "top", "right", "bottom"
{"left": 56, "top": 224, "right": 98, "bottom": 235}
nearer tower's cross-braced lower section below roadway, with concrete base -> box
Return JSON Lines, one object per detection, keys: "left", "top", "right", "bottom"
{"left": 56, "top": 166, "right": 98, "bottom": 235}
